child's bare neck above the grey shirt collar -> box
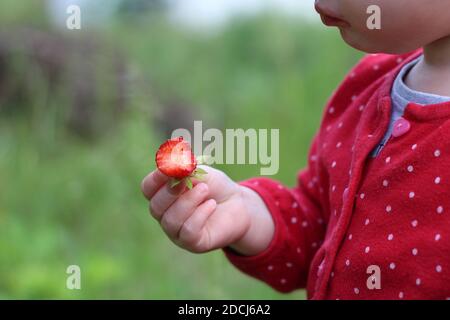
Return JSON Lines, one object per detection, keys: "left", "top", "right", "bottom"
{"left": 405, "top": 36, "right": 450, "bottom": 97}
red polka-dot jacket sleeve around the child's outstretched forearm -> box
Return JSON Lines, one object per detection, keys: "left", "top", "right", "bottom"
{"left": 224, "top": 138, "right": 325, "bottom": 292}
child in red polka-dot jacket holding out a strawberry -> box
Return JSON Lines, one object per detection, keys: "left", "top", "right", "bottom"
{"left": 142, "top": 0, "right": 450, "bottom": 299}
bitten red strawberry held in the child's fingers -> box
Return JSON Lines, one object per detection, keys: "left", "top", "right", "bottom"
{"left": 156, "top": 137, "right": 197, "bottom": 180}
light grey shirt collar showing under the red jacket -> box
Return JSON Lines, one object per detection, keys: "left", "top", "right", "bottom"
{"left": 372, "top": 56, "right": 450, "bottom": 157}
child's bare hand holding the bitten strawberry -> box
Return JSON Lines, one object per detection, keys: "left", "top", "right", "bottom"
{"left": 142, "top": 166, "right": 274, "bottom": 255}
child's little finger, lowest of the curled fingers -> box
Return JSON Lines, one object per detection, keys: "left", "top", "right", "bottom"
{"left": 178, "top": 199, "right": 217, "bottom": 252}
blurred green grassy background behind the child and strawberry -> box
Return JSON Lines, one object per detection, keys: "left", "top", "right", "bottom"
{"left": 0, "top": 0, "right": 361, "bottom": 299}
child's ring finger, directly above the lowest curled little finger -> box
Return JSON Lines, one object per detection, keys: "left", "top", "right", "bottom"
{"left": 161, "top": 183, "right": 208, "bottom": 240}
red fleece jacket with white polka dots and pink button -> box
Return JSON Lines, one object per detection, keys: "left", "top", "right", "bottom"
{"left": 225, "top": 52, "right": 450, "bottom": 299}
